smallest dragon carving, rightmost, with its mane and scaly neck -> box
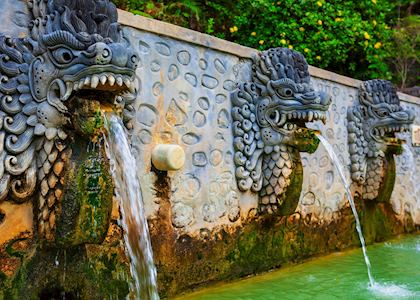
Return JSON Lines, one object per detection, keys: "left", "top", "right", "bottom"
{"left": 348, "top": 79, "right": 414, "bottom": 200}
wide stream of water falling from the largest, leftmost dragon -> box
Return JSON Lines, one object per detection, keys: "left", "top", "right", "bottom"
{"left": 105, "top": 115, "right": 159, "bottom": 300}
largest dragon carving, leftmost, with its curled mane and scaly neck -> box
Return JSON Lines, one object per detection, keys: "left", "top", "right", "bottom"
{"left": 0, "top": 0, "right": 139, "bottom": 239}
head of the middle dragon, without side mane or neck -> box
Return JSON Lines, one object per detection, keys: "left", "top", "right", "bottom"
{"left": 253, "top": 48, "right": 331, "bottom": 146}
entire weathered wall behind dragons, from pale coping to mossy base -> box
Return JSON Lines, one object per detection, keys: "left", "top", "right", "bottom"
{"left": 116, "top": 12, "right": 420, "bottom": 295}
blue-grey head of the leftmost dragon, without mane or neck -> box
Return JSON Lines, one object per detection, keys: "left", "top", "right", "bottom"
{"left": 29, "top": 0, "right": 139, "bottom": 131}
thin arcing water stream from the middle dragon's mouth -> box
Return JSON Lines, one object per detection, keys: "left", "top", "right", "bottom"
{"left": 317, "top": 134, "right": 375, "bottom": 287}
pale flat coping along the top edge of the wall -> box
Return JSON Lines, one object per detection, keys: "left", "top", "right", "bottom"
{"left": 118, "top": 9, "right": 420, "bottom": 105}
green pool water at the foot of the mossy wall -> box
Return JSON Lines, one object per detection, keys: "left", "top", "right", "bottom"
{"left": 178, "top": 235, "right": 420, "bottom": 300}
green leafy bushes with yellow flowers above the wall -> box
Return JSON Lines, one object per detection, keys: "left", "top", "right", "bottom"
{"left": 114, "top": 0, "right": 414, "bottom": 80}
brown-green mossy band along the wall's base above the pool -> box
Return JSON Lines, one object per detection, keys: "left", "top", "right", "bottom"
{"left": 150, "top": 186, "right": 414, "bottom": 297}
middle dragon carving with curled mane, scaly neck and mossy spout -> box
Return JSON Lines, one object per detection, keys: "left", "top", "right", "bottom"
{"left": 232, "top": 48, "right": 331, "bottom": 214}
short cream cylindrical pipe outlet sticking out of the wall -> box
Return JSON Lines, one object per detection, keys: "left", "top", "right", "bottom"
{"left": 152, "top": 144, "right": 185, "bottom": 171}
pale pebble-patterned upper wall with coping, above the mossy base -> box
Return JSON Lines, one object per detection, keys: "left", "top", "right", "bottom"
{"left": 120, "top": 12, "right": 420, "bottom": 227}
